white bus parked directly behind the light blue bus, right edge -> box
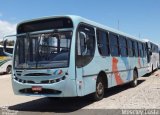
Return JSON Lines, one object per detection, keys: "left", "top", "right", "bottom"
{"left": 144, "top": 40, "right": 160, "bottom": 73}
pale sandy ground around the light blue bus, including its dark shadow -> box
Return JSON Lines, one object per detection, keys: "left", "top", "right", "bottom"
{"left": 0, "top": 70, "right": 160, "bottom": 115}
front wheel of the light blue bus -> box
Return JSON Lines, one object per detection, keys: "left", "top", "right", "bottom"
{"left": 92, "top": 77, "right": 105, "bottom": 101}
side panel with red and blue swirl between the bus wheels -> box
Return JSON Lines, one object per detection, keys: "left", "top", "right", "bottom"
{"left": 109, "top": 57, "right": 133, "bottom": 87}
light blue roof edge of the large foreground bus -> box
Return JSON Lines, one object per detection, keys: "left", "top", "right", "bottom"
{"left": 17, "top": 15, "right": 145, "bottom": 42}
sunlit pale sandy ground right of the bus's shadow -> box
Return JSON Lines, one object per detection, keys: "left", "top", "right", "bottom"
{"left": 85, "top": 70, "right": 160, "bottom": 109}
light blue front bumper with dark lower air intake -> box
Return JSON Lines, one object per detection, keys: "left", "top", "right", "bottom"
{"left": 12, "top": 76, "right": 77, "bottom": 97}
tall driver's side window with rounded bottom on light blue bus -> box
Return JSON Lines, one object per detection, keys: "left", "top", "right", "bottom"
{"left": 76, "top": 25, "right": 95, "bottom": 67}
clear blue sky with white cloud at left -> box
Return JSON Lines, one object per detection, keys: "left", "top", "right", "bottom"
{"left": 0, "top": 0, "right": 160, "bottom": 44}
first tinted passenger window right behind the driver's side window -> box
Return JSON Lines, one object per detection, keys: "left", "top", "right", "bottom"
{"left": 97, "top": 30, "right": 109, "bottom": 56}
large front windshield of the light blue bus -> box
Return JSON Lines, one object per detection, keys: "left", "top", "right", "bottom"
{"left": 14, "top": 31, "right": 72, "bottom": 69}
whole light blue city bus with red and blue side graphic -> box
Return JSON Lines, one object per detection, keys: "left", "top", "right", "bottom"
{"left": 4, "top": 15, "right": 151, "bottom": 100}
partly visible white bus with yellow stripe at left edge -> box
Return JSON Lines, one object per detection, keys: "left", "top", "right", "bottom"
{"left": 0, "top": 45, "right": 13, "bottom": 74}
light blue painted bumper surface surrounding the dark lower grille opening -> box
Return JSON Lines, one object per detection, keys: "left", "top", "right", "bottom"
{"left": 12, "top": 76, "right": 77, "bottom": 97}
